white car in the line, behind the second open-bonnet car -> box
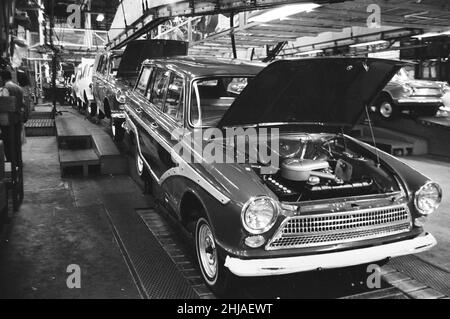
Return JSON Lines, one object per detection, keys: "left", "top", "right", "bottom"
{"left": 72, "top": 58, "right": 95, "bottom": 113}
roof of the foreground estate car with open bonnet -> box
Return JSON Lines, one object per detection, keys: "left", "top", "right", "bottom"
{"left": 143, "top": 56, "right": 266, "bottom": 78}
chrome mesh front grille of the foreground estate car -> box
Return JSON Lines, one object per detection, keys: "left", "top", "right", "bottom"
{"left": 266, "top": 205, "right": 411, "bottom": 250}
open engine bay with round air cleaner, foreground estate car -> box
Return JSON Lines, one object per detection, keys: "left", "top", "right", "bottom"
{"left": 260, "top": 134, "right": 399, "bottom": 202}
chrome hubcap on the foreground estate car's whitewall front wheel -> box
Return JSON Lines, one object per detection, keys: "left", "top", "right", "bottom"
{"left": 198, "top": 224, "right": 217, "bottom": 278}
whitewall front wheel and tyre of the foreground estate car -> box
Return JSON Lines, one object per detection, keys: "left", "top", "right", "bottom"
{"left": 195, "top": 217, "right": 231, "bottom": 294}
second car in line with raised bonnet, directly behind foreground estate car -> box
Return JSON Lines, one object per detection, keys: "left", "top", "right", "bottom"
{"left": 90, "top": 40, "right": 188, "bottom": 141}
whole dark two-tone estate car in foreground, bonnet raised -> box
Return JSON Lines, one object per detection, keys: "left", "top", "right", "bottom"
{"left": 124, "top": 57, "right": 442, "bottom": 292}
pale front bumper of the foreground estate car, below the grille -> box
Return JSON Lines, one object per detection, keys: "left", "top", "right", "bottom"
{"left": 225, "top": 233, "right": 436, "bottom": 277}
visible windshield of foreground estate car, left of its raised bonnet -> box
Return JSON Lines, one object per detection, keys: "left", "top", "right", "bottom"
{"left": 189, "top": 76, "right": 250, "bottom": 127}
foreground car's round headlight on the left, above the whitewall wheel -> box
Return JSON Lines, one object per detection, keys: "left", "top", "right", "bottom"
{"left": 241, "top": 196, "right": 278, "bottom": 234}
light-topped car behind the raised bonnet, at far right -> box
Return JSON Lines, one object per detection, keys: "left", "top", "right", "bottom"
{"left": 375, "top": 68, "right": 443, "bottom": 119}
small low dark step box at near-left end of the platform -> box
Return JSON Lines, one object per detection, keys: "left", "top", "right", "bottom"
{"left": 59, "top": 149, "right": 100, "bottom": 176}
